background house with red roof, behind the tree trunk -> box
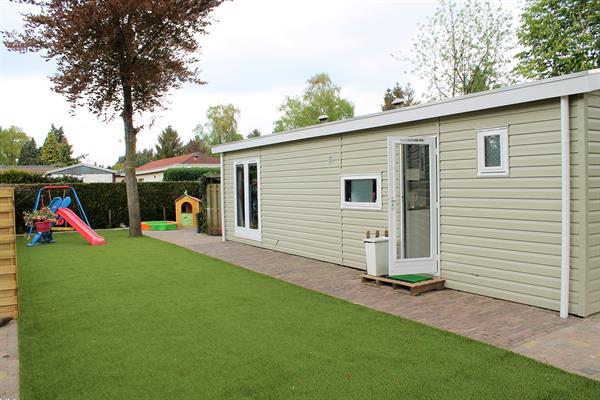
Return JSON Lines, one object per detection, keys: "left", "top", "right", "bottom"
{"left": 115, "top": 153, "right": 220, "bottom": 182}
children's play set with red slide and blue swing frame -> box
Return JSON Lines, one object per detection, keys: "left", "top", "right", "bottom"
{"left": 27, "top": 186, "right": 106, "bottom": 247}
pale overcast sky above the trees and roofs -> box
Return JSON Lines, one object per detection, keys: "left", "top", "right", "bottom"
{"left": 0, "top": 0, "right": 518, "bottom": 165}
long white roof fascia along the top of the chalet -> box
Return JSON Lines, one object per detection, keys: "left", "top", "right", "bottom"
{"left": 212, "top": 69, "right": 600, "bottom": 153}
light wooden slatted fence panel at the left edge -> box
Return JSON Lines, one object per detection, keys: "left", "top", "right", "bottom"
{"left": 0, "top": 187, "right": 19, "bottom": 319}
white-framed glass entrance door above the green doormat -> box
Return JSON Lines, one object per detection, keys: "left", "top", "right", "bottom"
{"left": 388, "top": 137, "right": 438, "bottom": 275}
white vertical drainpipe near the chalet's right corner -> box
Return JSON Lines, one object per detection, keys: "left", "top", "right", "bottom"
{"left": 560, "top": 96, "right": 571, "bottom": 318}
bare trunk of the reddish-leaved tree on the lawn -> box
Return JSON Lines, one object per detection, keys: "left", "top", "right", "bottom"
{"left": 121, "top": 86, "right": 142, "bottom": 237}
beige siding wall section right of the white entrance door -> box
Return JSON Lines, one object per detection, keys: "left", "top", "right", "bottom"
{"left": 440, "top": 99, "right": 585, "bottom": 314}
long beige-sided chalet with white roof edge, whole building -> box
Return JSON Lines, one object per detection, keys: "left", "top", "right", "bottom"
{"left": 213, "top": 70, "right": 600, "bottom": 317}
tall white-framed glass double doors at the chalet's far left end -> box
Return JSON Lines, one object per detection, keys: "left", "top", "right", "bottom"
{"left": 233, "top": 159, "right": 261, "bottom": 241}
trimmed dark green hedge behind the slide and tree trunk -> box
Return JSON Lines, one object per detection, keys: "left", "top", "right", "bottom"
{"left": 12, "top": 182, "right": 200, "bottom": 232}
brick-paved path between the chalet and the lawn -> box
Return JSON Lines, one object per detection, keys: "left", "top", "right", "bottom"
{"left": 146, "top": 229, "right": 600, "bottom": 380}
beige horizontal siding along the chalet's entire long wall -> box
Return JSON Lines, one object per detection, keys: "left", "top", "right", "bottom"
{"left": 224, "top": 96, "right": 600, "bottom": 315}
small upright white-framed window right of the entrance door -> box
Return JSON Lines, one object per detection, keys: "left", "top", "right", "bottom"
{"left": 477, "top": 128, "right": 509, "bottom": 176}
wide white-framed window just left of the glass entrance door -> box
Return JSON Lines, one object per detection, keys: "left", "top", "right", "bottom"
{"left": 341, "top": 174, "right": 381, "bottom": 210}
